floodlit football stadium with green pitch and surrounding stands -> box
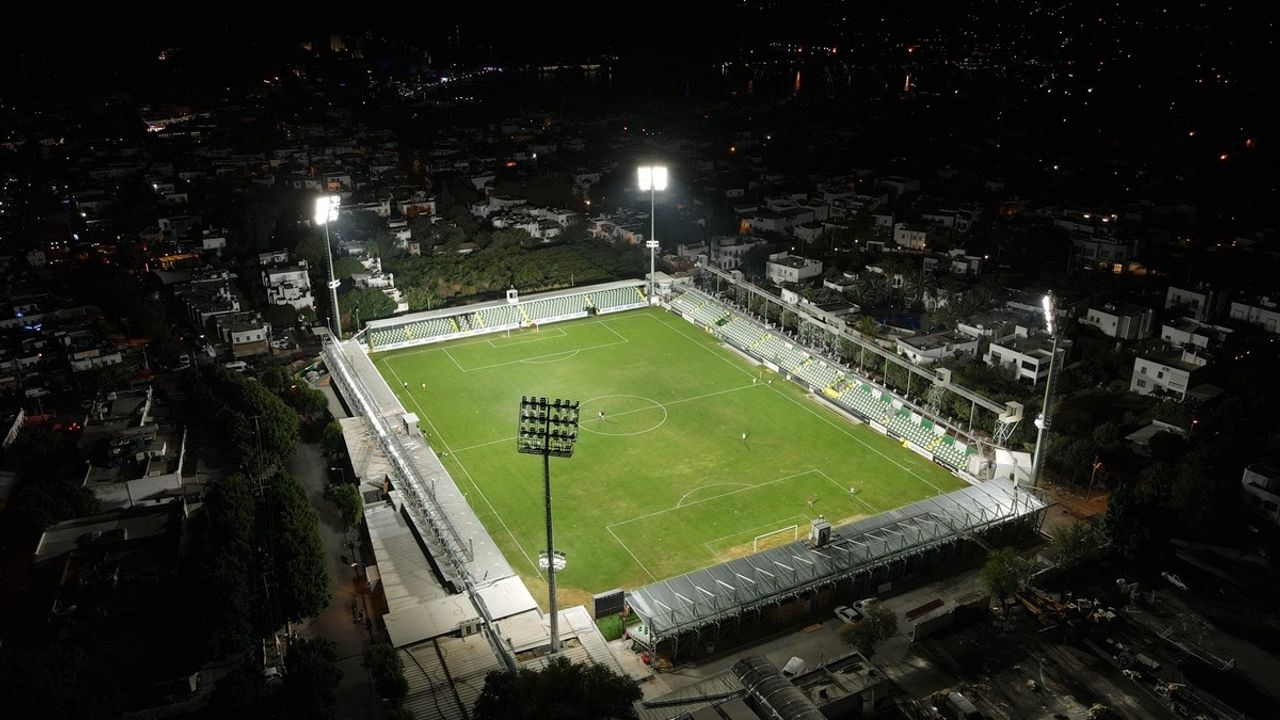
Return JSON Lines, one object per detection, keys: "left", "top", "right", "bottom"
{"left": 325, "top": 270, "right": 1044, "bottom": 665}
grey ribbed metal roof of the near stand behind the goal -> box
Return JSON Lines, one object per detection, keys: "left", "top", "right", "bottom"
{"left": 627, "top": 479, "right": 1046, "bottom": 643}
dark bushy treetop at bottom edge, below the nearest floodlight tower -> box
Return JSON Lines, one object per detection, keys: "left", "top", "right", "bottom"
{"left": 475, "top": 656, "right": 641, "bottom": 720}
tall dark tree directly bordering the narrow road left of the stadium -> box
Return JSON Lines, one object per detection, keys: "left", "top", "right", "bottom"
{"left": 264, "top": 473, "right": 332, "bottom": 621}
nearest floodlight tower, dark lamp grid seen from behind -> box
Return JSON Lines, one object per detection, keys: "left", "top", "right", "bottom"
{"left": 516, "top": 396, "right": 579, "bottom": 655}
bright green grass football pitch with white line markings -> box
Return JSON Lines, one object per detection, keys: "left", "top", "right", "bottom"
{"left": 374, "top": 310, "right": 963, "bottom": 600}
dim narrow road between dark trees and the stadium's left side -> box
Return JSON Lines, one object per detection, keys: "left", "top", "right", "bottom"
{"left": 289, "top": 442, "right": 378, "bottom": 719}
